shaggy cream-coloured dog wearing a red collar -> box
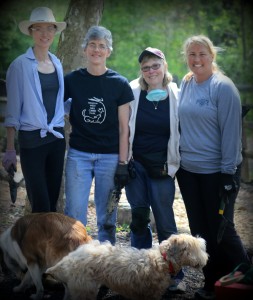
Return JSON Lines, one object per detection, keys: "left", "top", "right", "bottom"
{"left": 44, "top": 234, "right": 208, "bottom": 300}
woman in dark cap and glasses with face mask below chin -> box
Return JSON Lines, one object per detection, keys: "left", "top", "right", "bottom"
{"left": 126, "top": 47, "right": 185, "bottom": 291}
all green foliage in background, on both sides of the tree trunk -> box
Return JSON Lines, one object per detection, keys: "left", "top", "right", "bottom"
{"left": 0, "top": 0, "right": 253, "bottom": 91}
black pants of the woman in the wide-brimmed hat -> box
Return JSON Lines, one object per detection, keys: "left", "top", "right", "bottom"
{"left": 20, "top": 139, "right": 66, "bottom": 212}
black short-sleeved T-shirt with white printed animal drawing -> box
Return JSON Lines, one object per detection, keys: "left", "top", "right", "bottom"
{"left": 64, "top": 69, "right": 134, "bottom": 153}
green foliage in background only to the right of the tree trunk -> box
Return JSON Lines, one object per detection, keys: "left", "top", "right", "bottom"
{"left": 101, "top": 0, "right": 253, "bottom": 88}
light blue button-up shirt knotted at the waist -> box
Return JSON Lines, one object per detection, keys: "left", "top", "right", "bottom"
{"left": 4, "top": 48, "right": 64, "bottom": 138}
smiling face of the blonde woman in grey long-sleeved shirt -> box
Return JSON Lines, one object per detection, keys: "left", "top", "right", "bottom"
{"left": 187, "top": 43, "right": 213, "bottom": 82}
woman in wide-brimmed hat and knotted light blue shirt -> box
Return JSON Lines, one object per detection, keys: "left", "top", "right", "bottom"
{"left": 2, "top": 7, "right": 66, "bottom": 212}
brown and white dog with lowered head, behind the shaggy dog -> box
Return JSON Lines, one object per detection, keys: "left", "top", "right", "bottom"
{"left": 0, "top": 212, "right": 92, "bottom": 300}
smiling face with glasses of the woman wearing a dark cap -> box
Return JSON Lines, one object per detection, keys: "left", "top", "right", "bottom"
{"left": 141, "top": 57, "right": 165, "bottom": 89}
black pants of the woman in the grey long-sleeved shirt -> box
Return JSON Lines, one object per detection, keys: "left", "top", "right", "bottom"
{"left": 176, "top": 167, "right": 250, "bottom": 290}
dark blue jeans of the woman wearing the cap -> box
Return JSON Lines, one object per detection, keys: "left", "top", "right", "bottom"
{"left": 125, "top": 161, "right": 177, "bottom": 249}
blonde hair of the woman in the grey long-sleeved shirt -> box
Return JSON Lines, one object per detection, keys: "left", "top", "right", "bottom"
{"left": 182, "top": 35, "right": 224, "bottom": 81}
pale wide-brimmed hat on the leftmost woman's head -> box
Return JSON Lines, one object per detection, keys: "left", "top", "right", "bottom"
{"left": 18, "top": 7, "right": 66, "bottom": 35}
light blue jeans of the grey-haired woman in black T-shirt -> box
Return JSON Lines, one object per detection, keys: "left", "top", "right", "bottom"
{"left": 65, "top": 148, "right": 118, "bottom": 244}
